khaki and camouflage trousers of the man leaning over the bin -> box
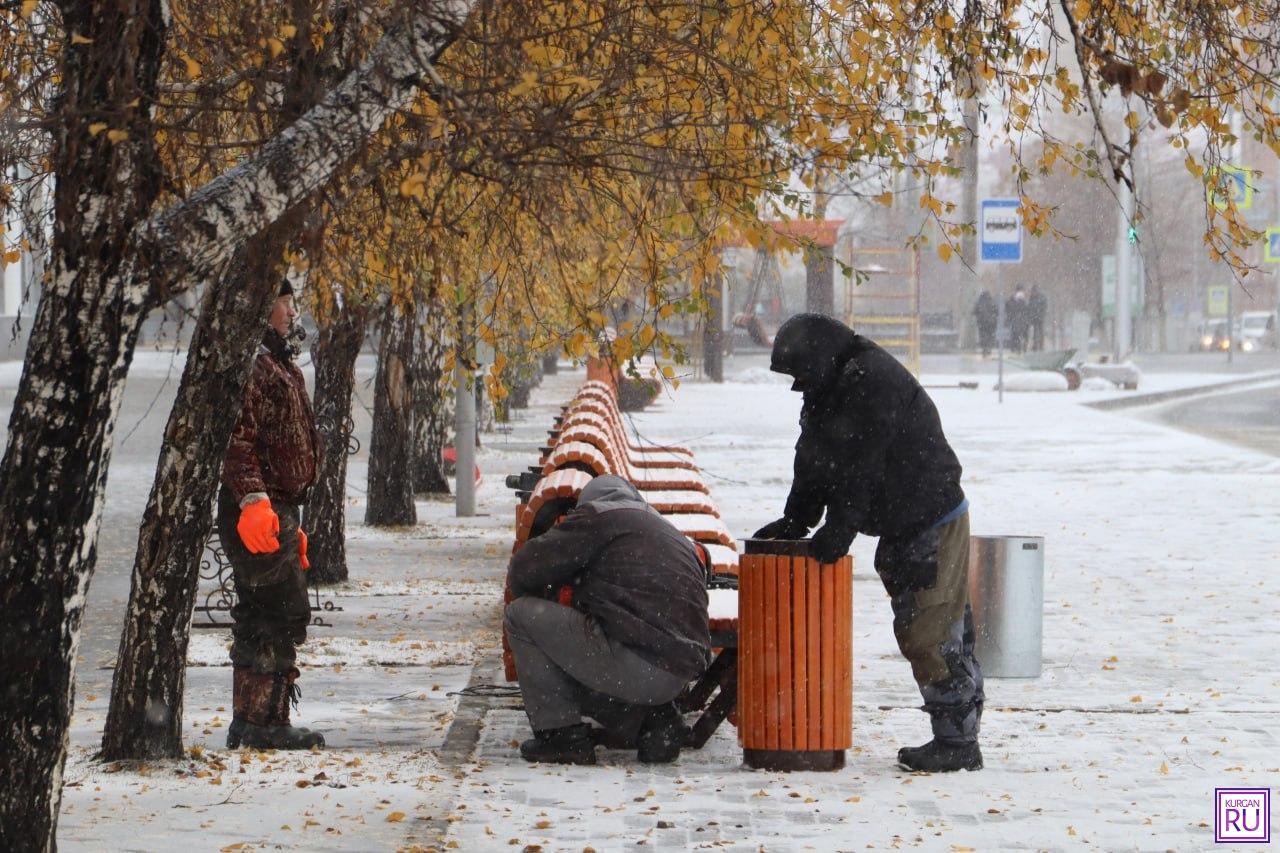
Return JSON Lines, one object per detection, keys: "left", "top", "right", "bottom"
{"left": 876, "top": 512, "right": 984, "bottom": 743}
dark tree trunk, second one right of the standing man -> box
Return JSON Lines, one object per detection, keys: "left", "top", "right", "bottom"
{"left": 365, "top": 301, "right": 417, "bottom": 526}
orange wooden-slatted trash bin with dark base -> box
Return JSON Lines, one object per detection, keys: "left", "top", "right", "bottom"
{"left": 737, "top": 539, "right": 854, "bottom": 770}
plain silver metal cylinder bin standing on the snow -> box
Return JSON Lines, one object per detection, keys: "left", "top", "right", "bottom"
{"left": 969, "top": 535, "right": 1044, "bottom": 679}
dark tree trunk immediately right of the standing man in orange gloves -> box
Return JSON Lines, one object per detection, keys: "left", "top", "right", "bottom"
{"left": 302, "top": 305, "right": 370, "bottom": 584}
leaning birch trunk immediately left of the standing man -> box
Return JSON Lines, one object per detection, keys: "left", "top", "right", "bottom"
{"left": 102, "top": 214, "right": 297, "bottom": 761}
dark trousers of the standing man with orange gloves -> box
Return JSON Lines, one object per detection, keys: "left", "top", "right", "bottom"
{"left": 218, "top": 489, "right": 311, "bottom": 674}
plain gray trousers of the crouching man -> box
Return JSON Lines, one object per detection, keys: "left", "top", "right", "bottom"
{"left": 506, "top": 596, "right": 687, "bottom": 731}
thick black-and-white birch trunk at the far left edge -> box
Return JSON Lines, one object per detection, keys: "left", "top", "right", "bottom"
{"left": 0, "top": 0, "right": 165, "bottom": 850}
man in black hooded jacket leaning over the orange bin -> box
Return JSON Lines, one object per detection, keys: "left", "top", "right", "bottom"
{"left": 755, "top": 314, "right": 983, "bottom": 771}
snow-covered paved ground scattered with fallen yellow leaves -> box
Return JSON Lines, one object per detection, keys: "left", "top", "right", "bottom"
{"left": 59, "top": 350, "right": 1280, "bottom": 853}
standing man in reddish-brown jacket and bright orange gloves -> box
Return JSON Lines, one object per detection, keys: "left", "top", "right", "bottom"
{"left": 218, "top": 280, "right": 324, "bottom": 749}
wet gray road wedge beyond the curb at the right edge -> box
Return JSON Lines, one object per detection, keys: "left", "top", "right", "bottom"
{"left": 1157, "top": 384, "right": 1280, "bottom": 456}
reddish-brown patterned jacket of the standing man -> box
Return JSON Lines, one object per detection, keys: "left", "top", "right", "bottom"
{"left": 223, "top": 334, "right": 320, "bottom": 503}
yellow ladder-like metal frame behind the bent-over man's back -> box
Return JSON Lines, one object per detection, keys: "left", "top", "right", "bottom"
{"left": 845, "top": 245, "right": 920, "bottom": 377}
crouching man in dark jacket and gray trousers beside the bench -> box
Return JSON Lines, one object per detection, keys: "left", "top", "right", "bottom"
{"left": 506, "top": 475, "right": 710, "bottom": 765}
